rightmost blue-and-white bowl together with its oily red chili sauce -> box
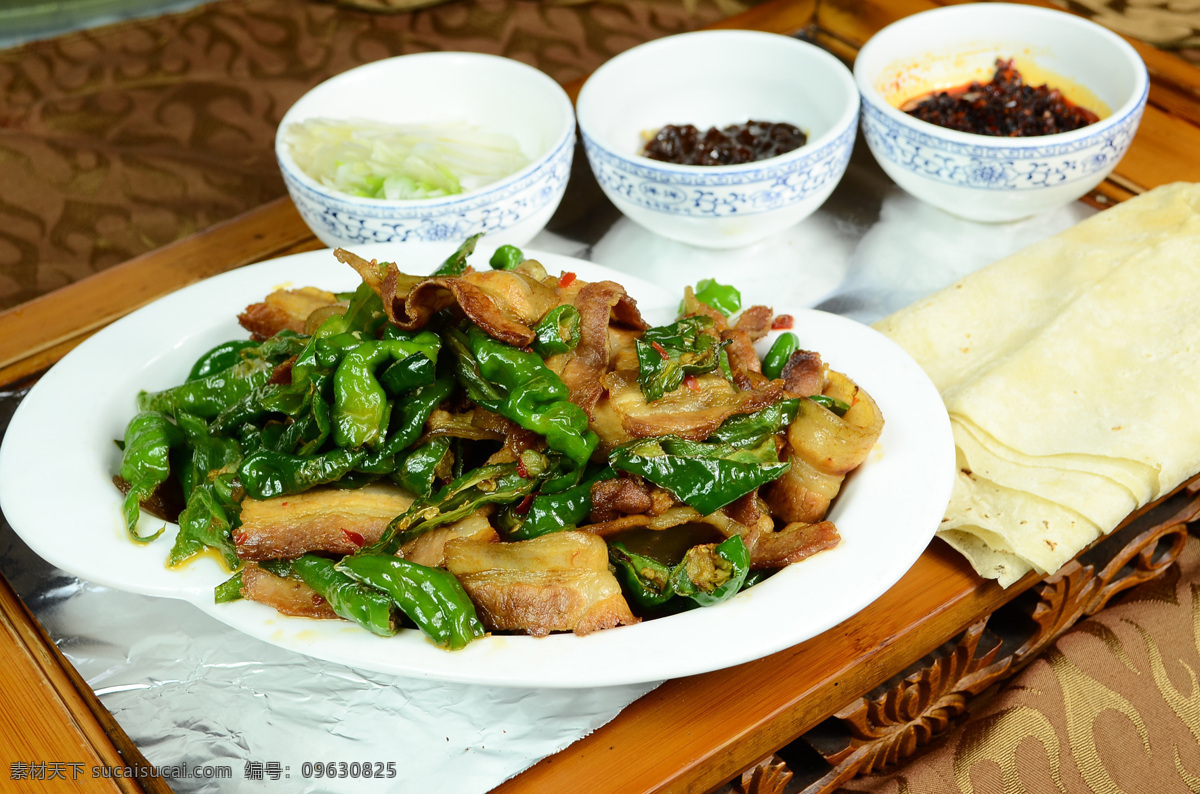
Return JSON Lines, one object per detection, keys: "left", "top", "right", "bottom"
{"left": 854, "top": 2, "right": 1150, "bottom": 222}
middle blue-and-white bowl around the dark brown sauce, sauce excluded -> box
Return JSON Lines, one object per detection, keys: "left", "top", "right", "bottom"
{"left": 576, "top": 30, "right": 858, "bottom": 248}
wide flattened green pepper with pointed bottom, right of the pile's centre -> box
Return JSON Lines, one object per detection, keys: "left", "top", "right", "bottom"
{"left": 608, "top": 435, "right": 791, "bottom": 516}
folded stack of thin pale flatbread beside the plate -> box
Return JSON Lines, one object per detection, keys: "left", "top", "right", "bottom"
{"left": 876, "top": 184, "right": 1200, "bottom": 587}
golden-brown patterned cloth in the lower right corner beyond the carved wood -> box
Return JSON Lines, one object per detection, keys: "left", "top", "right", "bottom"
{"left": 844, "top": 537, "right": 1200, "bottom": 794}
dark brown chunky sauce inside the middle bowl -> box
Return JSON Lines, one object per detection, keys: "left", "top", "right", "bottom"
{"left": 642, "top": 121, "right": 808, "bottom": 166}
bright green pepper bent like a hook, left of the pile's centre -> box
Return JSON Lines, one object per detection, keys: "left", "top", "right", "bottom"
{"left": 332, "top": 332, "right": 442, "bottom": 450}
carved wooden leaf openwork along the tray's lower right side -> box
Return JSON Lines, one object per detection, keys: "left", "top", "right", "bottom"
{"left": 732, "top": 477, "right": 1200, "bottom": 794}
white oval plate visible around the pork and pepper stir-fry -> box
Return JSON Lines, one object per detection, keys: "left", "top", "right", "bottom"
{"left": 0, "top": 243, "right": 954, "bottom": 687}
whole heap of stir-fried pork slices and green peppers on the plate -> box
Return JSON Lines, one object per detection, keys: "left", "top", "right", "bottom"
{"left": 115, "top": 239, "right": 883, "bottom": 648}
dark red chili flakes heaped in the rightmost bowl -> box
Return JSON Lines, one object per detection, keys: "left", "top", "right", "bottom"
{"left": 900, "top": 59, "right": 1100, "bottom": 138}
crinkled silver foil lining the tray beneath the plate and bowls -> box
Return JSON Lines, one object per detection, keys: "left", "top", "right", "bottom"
{"left": 0, "top": 139, "right": 1092, "bottom": 794}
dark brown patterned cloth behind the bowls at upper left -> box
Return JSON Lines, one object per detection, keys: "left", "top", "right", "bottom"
{"left": 0, "top": 0, "right": 754, "bottom": 309}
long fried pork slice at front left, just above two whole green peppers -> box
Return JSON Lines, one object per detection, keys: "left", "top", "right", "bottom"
{"left": 234, "top": 483, "right": 415, "bottom": 560}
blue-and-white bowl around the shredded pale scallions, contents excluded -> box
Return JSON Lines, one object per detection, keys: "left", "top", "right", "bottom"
{"left": 275, "top": 53, "right": 575, "bottom": 247}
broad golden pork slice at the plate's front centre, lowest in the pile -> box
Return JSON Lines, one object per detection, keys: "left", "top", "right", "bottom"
{"left": 445, "top": 531, "right": 637, "bottom": 637}
